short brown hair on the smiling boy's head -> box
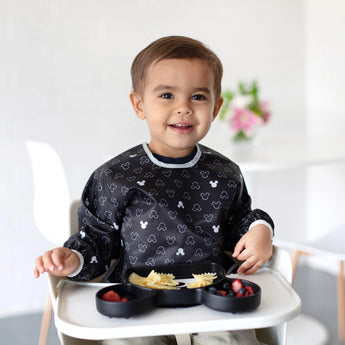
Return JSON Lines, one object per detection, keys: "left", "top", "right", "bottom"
{"left": 131, "top": 36, "right": 223, "bottom": 98}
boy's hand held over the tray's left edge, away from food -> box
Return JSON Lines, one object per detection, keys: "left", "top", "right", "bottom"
{"left": 34, "top": 247, "right": 80, "bottom": 278}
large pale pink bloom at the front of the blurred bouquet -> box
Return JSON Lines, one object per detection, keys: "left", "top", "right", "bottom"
{"left": 231, "top": 107, "right": 262, "bottom": 137}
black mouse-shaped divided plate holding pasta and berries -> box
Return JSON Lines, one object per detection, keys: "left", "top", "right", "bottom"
{"left": 96, "top": 263, "right": 261, "bottom": 318}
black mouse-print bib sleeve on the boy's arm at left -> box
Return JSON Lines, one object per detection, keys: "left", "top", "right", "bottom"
{"left": 64, "top": 165, "right": 122, "bottom": 280}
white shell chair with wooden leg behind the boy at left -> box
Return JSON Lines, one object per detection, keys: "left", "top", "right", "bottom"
{"left": 26, "top": 141, "right": 71, "bottom": 345}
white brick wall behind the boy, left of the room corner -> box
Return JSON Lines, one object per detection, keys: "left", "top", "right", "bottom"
{"left": 0, "top": 0, "right": 330, "bottom": 315}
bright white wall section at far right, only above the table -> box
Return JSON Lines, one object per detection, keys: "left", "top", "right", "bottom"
{"left": 305, "top": 0, "right": 345, "bottom": 134}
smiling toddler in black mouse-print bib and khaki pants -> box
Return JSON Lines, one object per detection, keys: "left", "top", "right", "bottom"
{"left": 34, "top": 36, "right": 274, "bottom": 345}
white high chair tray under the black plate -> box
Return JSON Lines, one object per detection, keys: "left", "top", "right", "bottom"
{"left": 55, "top": 268, "right": 301, "bottom": 339}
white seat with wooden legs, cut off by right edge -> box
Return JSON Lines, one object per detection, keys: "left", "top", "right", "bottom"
{"left": 276, "top": 227, "right": 345, "bottom": 342}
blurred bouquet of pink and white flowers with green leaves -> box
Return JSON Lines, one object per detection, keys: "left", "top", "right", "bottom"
{"left": 219, "top": 80, "right": 271, "bottom": 141}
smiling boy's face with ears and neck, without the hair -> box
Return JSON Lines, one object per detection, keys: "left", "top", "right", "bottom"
{"left": 130, "top": 59, "right": 223, "bottom": 158}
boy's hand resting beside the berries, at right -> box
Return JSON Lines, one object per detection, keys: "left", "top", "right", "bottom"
{"left": 232, "top": 224, "right": 273, "bottom": 274}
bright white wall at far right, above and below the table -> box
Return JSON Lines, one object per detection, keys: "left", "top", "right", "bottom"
{"left": 305, "top": 0, "right": 345, "bottom": 239}
